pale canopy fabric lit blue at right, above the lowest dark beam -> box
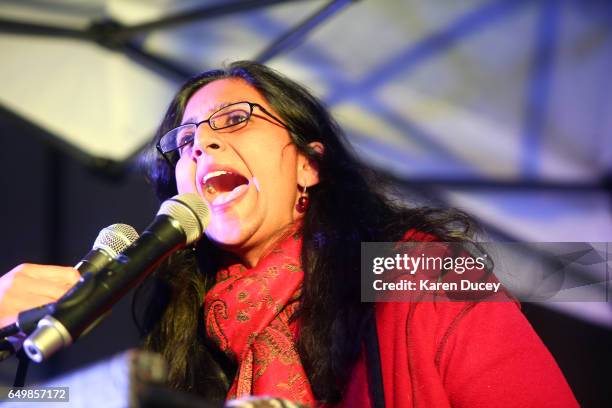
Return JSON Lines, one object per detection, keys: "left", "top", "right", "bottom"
{"left": 0, "top": 0, "right": 612, "bottom": 172}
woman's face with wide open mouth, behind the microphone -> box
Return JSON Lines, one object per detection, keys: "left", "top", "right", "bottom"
{"left": 176, "top": 79, "right": 318, "bottom": 266}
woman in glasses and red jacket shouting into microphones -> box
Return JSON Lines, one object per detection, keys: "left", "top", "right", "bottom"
{"left": 0, "top": 62, "right": 577, "bottom": 407}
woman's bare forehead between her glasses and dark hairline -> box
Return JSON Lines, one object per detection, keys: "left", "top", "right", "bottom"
{"left": 183, "top": 78, "right": 265, "bottom": 120}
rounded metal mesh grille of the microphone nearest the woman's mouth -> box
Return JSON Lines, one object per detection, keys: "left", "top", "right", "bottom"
{"left": 157, "top": 193, "right": 210, "bottom": 245}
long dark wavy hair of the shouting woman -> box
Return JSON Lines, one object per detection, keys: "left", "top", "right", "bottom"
{"left": 142, "top": 61, "right": 471, "bottom": 403}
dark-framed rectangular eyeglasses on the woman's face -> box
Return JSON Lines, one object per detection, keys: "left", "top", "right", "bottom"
{"left": 156, "top": 102, "right": 289, "bottom": 165}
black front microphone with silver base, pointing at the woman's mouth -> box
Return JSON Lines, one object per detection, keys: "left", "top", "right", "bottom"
{"left": 23, "top": 193, "right": 210, "bottom": 363}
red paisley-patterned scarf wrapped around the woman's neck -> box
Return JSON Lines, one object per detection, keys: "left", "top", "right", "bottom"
{"left": 204, "top": 234, "right": 315, "bottom": 406}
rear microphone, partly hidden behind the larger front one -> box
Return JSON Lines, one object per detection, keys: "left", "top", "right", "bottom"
{"left": 15, "top": 224, "right": 138, "bottom": 334}
